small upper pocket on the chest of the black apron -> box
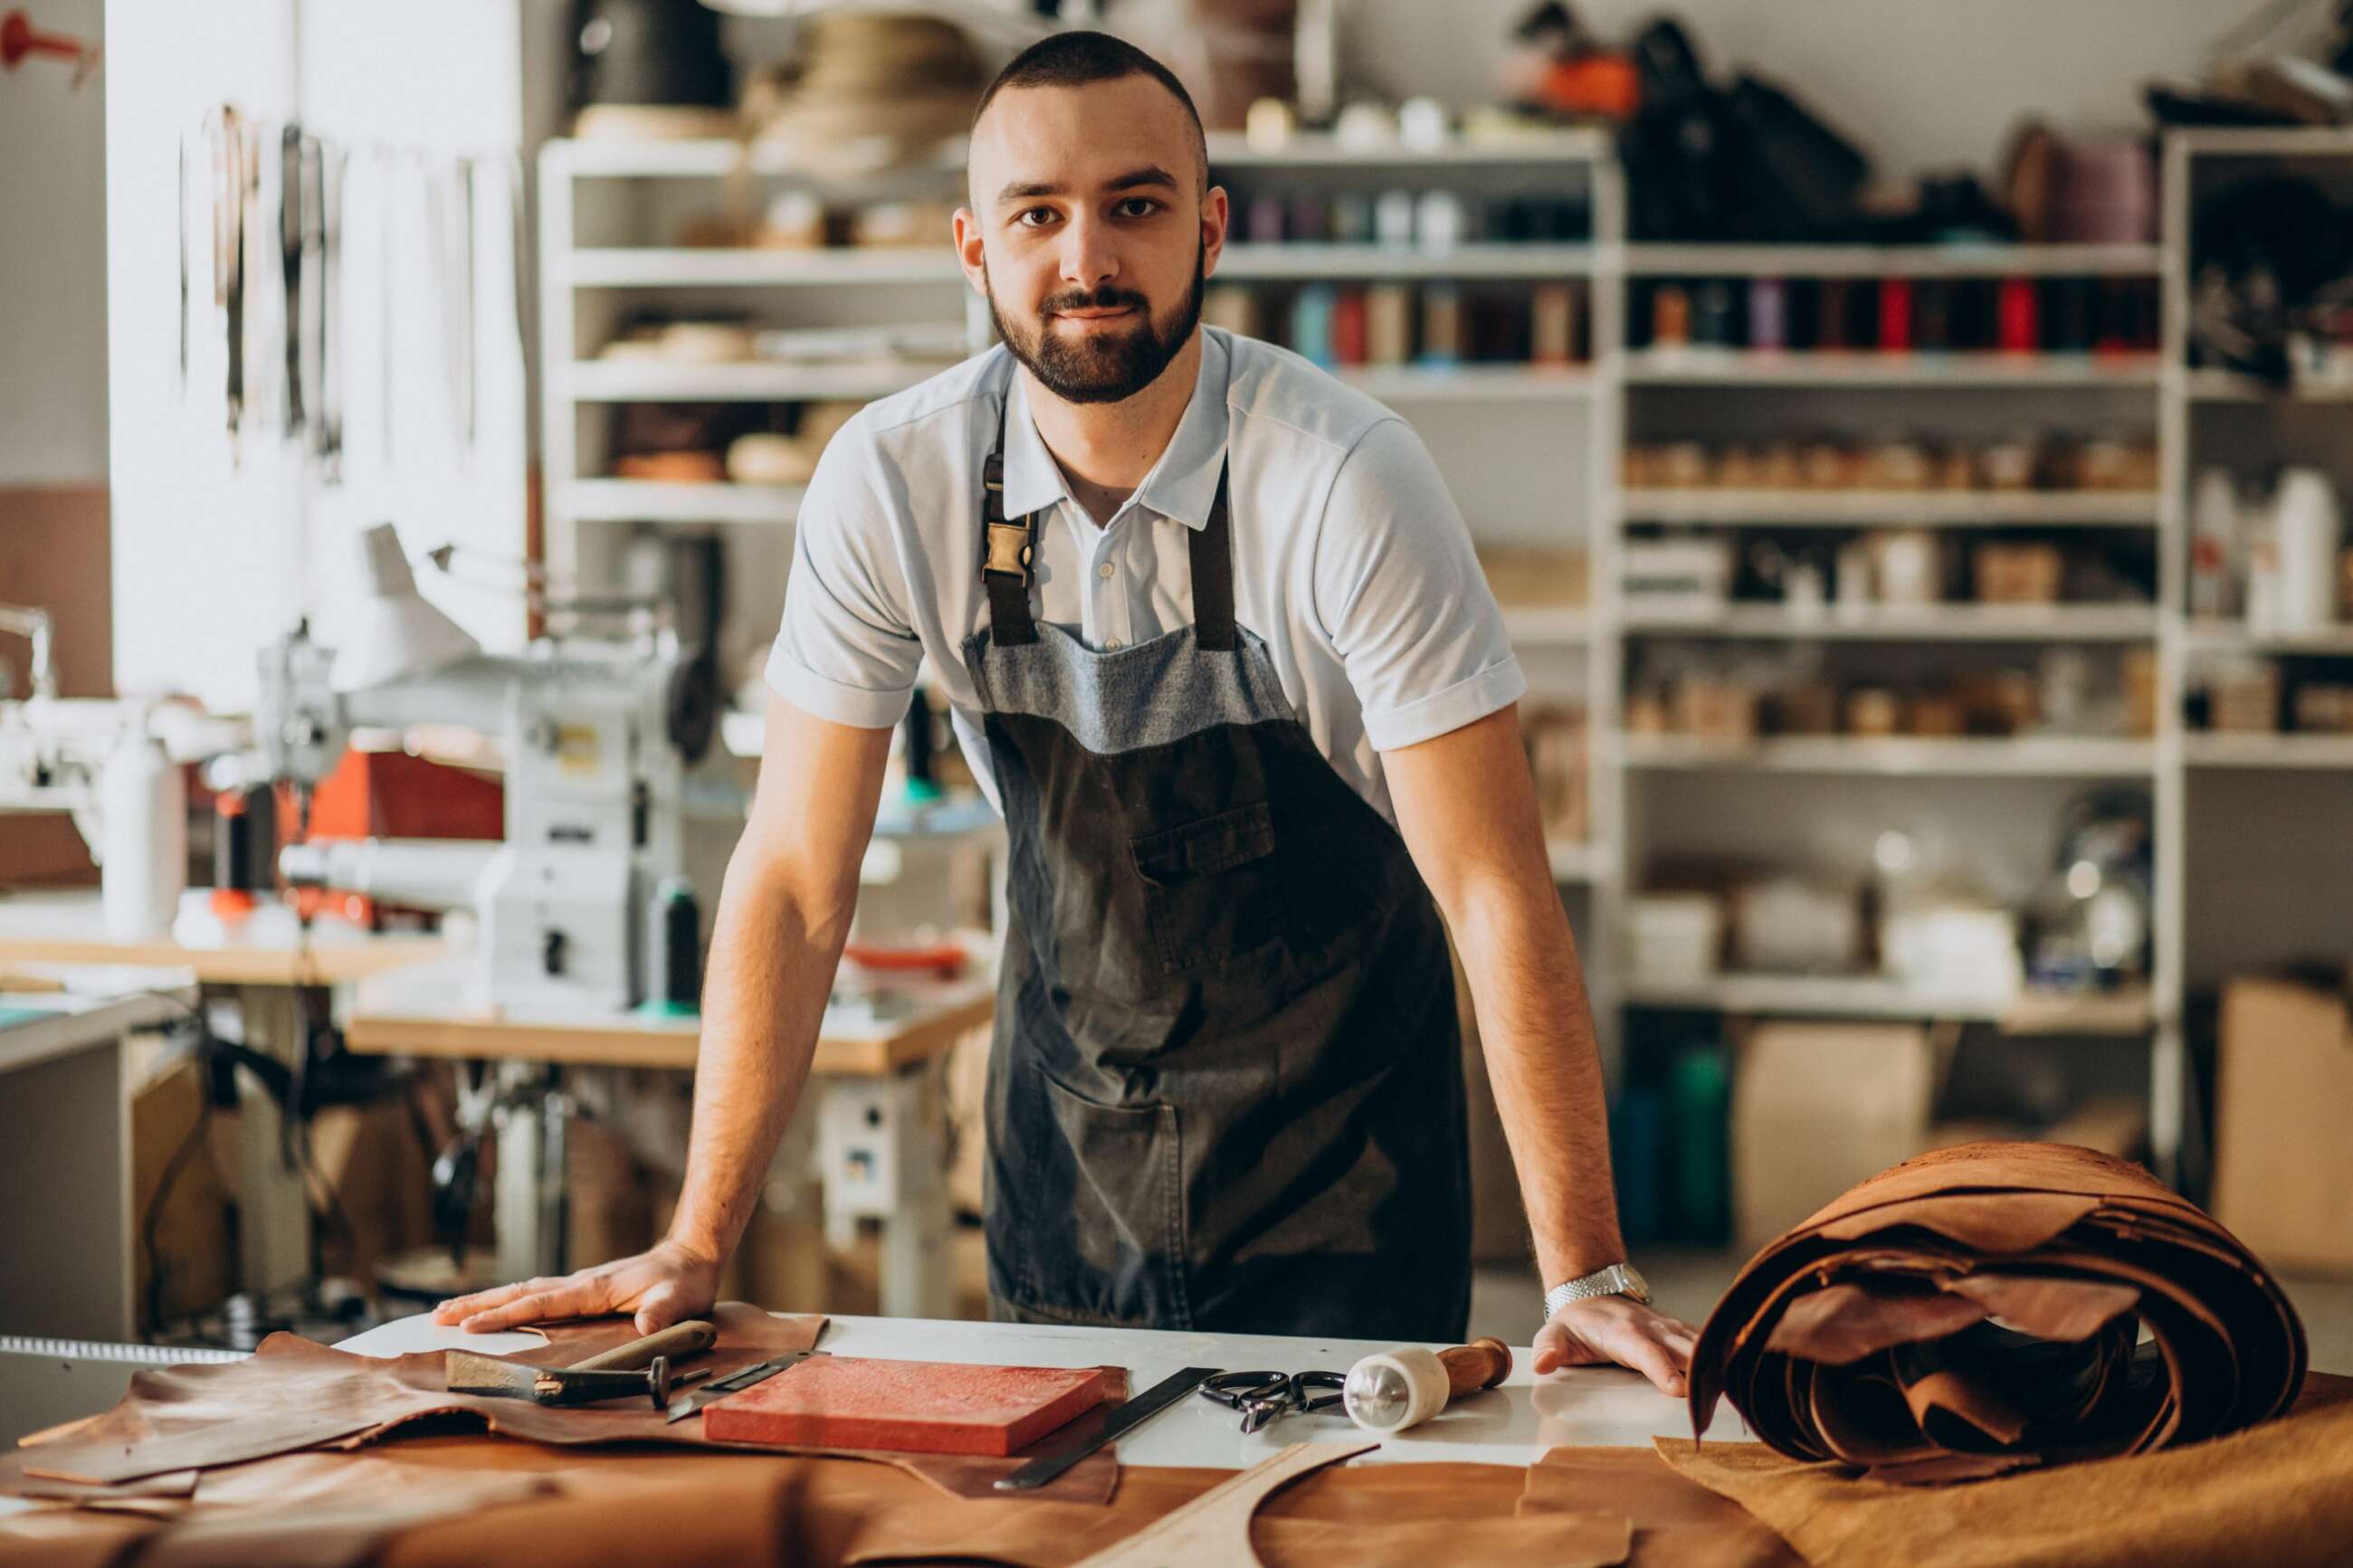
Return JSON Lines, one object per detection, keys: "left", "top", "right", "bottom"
{"left": 1127, "top": 799, "right": 1287, "bottom": 974}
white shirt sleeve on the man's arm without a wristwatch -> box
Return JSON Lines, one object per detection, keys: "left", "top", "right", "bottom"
{"left": 765, "top": 418, "right": 922, "bottom": 728}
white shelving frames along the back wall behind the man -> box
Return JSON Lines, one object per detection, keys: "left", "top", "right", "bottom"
{"left": 541, "top": 131, "right": 2353, "bottom": 1189}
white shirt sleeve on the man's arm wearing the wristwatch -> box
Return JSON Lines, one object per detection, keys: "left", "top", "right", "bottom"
{"left": 1315, "top": 418, "right": 1527, "bottom": 750}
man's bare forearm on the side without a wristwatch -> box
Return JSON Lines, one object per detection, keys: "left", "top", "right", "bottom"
{"left": 671, "top": 849, "right": 856, "bottom": 1260}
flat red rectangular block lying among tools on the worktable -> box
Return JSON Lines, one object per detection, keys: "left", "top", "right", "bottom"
{"left": 703, "top": 1356, "right": 1118, "bottom": 1455}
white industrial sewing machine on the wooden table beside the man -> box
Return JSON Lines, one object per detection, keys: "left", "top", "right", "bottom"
{"left": 254, "top": 527, "right": 715, "bottom": 1009}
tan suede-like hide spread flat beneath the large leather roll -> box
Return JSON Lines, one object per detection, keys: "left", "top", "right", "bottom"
{"left": 1659, "top": 1373, "right": 2353, "bottom": 1568}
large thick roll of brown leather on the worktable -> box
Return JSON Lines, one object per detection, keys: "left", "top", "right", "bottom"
{"left": 1691, "top": 1143, "right": 2306, "bottom": 1481}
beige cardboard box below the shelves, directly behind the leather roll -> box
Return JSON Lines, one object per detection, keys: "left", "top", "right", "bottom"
{"left": 1732, "top": 1021, "right": 1937, "bottom": 1250}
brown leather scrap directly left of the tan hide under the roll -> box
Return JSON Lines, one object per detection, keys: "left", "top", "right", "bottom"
{"left": 1515, "top": 1448, "right": 1803, "bottom": 1568}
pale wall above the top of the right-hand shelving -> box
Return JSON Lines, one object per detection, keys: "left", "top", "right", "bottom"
{"left": 1341, "top": 0, "right": 2268, "bottom": 178}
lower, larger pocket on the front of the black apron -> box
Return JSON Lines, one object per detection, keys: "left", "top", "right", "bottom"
{"left": 1028, "top": 1074, "right": 1193, "bottom": 1328}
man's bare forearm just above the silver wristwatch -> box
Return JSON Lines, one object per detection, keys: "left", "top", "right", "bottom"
{"left": 1454, "top": 884, "right": 1626, "bottom": 1286}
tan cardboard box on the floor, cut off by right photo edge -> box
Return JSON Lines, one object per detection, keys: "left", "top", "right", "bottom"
{"left": 2215, "top": 978, "right": 2353, "bottom": 1274}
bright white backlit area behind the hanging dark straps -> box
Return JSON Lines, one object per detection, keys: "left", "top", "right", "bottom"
{"left": 106, "top": 0, "right": 525, "bottom": 710}
